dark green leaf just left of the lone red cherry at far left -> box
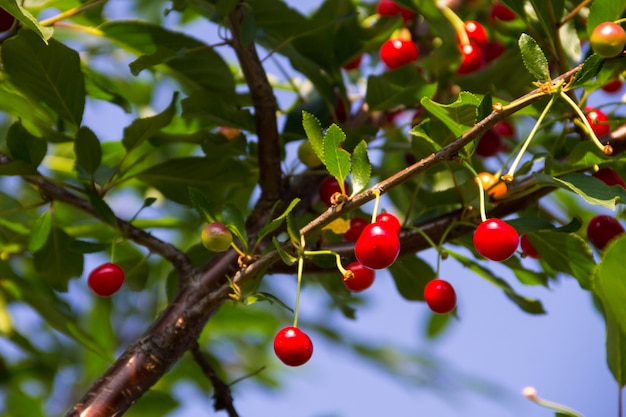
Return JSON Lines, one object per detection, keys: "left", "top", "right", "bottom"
{"left": 33, "top": 227, "right": 83, "bottom": 292}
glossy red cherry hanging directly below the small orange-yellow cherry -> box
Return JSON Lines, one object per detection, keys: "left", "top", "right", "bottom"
{"left": 474, "top": 219, "right": 519, "bottom": 261}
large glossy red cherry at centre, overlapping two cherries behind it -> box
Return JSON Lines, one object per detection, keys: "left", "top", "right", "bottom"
{"left": 354, "top": 223, "right": 400, "bottom": 269}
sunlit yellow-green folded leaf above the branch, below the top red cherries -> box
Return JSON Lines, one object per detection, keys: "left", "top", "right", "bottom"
{"left": 420, "top": 91, "right": 480, "bottom": 137}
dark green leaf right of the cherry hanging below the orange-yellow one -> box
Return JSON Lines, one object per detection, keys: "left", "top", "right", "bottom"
{"left": 528, "top": 230, "right": 595, "bottom": 289}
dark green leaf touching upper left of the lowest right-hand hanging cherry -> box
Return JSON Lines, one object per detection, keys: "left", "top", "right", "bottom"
{"left": 389, "top": 256, "right": 435, "bottom": 301}
